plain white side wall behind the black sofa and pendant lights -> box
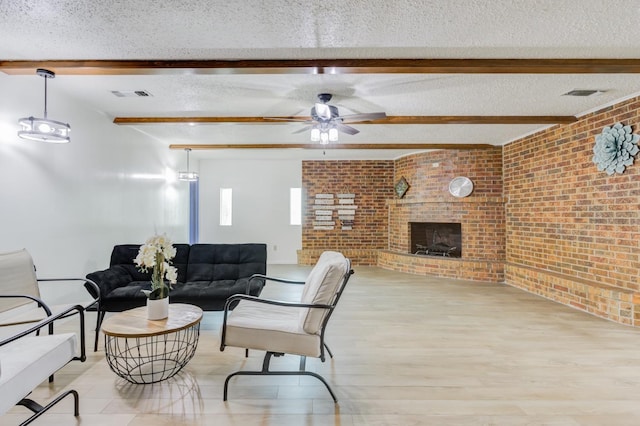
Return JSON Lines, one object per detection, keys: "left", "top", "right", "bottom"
{"left": 0, "top": 74, "right": 188, "bottom": 278}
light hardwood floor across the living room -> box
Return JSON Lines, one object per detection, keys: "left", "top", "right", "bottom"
{"left": 0, "top": 266, "right": 640, "bottom": 426}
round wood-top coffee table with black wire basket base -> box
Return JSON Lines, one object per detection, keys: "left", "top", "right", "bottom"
{"left": 102, "top": 303, "right": 202, "bottom": 384}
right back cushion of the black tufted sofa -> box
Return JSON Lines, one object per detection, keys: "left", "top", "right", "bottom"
{"left": 186, "top": 243, "right": 267, "bottom": 282}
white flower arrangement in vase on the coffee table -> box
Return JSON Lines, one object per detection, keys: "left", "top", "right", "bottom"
{"left": 133, "top": 235, "right": 178, "bottom": 300}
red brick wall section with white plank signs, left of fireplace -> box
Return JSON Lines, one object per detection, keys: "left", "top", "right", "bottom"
{"left": 298, "top": 161, "right": 393, "bottom": 265}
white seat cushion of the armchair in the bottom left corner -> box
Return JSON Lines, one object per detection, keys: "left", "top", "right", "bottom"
{"left": 0, "top": 333, "right": 77, "bottom": 414}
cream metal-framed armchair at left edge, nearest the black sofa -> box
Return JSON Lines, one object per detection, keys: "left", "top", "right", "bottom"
{"left": 0, "top": 249, "right": 99, "bottom": 334}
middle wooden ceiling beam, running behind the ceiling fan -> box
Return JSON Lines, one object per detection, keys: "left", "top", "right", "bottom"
{"left": 113, "top": 115, "right": 578, "bottom": 125}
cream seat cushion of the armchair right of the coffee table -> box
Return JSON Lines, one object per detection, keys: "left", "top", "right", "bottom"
{"left": 225, "top": 300, "right": 320, "bottom": 358}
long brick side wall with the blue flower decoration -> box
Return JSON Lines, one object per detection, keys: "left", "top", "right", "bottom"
{"left": 503, "top": 98, "right": 640, "bottom": 324}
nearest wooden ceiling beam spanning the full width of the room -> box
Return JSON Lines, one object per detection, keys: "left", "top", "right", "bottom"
{"left": 0, "top": 58, "right": 640, "bottom": 75}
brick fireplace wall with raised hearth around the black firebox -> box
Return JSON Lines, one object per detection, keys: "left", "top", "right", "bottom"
{"left": 378, "top": 147, "right": 505, "bottom": 281}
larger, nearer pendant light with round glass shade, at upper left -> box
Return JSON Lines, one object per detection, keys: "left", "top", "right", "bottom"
{"left": 18, "top": 68, "right": 71, "bottom": 143}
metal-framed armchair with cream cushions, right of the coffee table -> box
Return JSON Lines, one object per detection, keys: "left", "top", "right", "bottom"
{"left": 220, "top": 251, "right": 353, "bottom": 403}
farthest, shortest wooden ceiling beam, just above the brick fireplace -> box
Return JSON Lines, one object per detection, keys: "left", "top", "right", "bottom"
{"left": 169, "top": 143, "right": 495, "bottom": 151}
